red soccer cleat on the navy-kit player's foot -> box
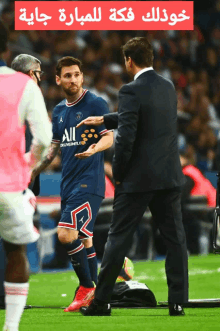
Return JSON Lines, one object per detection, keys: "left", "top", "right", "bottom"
{"left": 64, "top": 286, "right": 95, "bottom": 312}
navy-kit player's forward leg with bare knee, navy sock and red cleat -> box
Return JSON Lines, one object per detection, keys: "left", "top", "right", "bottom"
{"left": 57, "top": 227, "right": 94, "bottom": 312}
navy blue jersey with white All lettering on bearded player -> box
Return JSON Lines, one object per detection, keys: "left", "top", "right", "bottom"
{"left": 52, "top": 90, "right": 109, "bottom": 200}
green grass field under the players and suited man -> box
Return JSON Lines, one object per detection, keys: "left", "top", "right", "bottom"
{"left": 0, "top": 255, "right": 220, "bottom": 331}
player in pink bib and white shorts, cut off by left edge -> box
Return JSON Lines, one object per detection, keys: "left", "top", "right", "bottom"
{"left": 0, "top": 21, "right": 52, "bottom": 331}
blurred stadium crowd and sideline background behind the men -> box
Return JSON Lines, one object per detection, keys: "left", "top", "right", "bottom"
{"left": 0, "top": 0, "right": 220, "bottom": 272}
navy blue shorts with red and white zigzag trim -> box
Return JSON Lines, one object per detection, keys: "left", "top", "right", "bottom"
{"left": 58, "top": 192, "right": 103, "bottom": 239}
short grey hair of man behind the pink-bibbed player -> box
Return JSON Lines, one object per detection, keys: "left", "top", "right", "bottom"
{"left": 11, "top": 54, "right": 41, "bottom": 74}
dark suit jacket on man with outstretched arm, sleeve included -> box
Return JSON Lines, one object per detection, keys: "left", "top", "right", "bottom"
{"left": 104, "top": 70, "right": 185, "bottom": 192}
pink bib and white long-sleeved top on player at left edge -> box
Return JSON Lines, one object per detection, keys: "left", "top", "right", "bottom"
{"left": 0, "top": 66, "right": 51, "bottom": 192}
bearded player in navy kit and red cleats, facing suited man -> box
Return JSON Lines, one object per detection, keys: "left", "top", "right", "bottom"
{"left": 32, "top": 56, "right": 113, "bottom": 311}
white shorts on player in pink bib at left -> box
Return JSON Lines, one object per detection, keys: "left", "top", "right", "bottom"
{"left": 0, "top": 189, "right": 39, "bottom": 245}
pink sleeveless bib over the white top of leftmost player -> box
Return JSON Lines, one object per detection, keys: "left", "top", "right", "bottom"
{"left": 0, "top": 67, "right": 29, "bottom": 191}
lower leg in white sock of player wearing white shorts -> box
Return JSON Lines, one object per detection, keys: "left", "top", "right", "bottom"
{"left": 4, "top": 241, "right": 29, "bottom": 331}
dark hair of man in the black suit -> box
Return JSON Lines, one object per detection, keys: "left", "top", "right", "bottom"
{"left": 122, "top": 37, "right": 154, "bottom": 68}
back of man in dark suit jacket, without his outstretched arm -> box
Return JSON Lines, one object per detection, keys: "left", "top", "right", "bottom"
{"left": 114, "top": 70, "right": 184, "bottom": 192}
